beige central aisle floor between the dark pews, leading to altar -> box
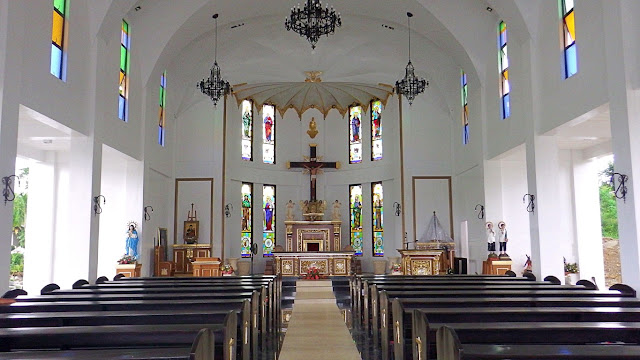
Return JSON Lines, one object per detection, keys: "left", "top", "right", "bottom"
{"left": 279, "top": 280, "right": 361, "bottom": 360}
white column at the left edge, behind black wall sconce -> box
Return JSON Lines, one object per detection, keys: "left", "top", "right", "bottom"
{"left": 0, "top": 0, "right": 24, "bottom": 294}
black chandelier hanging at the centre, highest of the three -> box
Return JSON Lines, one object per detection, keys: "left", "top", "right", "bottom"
{"left": 284, "top": 0, "right": 342, "bottom": 49}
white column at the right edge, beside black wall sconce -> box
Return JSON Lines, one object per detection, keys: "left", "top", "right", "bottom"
{"left": 602, "top": 0, "right": 640, "bottom": 289}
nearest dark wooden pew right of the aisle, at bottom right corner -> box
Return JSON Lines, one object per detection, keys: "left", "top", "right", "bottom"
{"left": 438, "top": 326, "right": 640, "bottom": 360}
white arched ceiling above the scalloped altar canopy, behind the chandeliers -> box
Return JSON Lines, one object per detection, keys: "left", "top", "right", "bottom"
{"left": 99, "top": 0, "right": 529, "bottom": 115}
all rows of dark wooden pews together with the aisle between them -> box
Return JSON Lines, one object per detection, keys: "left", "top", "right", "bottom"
{"left": 0, "top": 274, "right": 640, "bottom": 360}
